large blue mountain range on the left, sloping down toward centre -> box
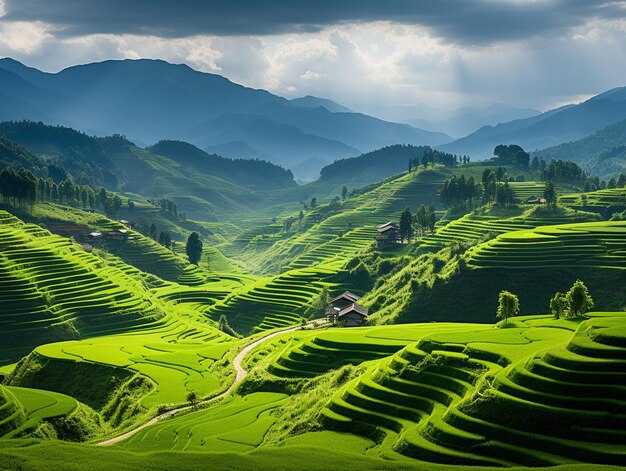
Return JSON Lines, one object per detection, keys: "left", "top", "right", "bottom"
{"left": 0, "top": 58, "right": 452, "bottom": 179}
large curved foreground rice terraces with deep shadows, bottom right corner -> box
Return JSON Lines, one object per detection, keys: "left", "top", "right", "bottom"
{"left": 320, "top": 314, "right": 626, "bottom": 466}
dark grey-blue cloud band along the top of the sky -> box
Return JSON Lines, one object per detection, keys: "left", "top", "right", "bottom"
{"left": 2, "top": 0, "right": 626, "bottom": 44}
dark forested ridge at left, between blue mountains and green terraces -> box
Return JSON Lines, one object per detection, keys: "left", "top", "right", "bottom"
{"left": 0, "top": 121, "right": 295, "bottom": 220}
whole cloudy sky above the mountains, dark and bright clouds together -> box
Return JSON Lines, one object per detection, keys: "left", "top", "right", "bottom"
{"left": 0, "top": 0, "right": 626, "bottom": 111}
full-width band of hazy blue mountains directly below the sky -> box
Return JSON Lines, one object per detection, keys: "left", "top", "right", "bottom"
{"left": 0, "top": 54, "right": 626, "bottom": 181}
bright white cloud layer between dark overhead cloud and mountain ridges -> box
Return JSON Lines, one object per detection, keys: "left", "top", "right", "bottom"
{"left": 0, "top": 17, "right": 626, "bottom": 111}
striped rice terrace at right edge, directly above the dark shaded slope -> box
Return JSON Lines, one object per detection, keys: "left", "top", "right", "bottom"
{"left": 467, "top": 221, "right": 626, "bottom": 269}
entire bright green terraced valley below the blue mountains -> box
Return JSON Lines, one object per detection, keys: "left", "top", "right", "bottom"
{"left": 0, "top": 160, "right": 626, "bottom": 471}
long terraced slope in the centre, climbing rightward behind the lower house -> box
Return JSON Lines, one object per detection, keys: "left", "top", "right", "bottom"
{"left": 205, "top": 170, "right": 444, "bottom": 335}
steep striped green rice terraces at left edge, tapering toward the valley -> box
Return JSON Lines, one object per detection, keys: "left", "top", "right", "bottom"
{"left": 0, "top": 211, "right": 163, "bottom": 364}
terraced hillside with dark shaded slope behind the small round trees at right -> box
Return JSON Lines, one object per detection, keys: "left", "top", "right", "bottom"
{"left": 363, "top": 216, "right": 626, "bottom": 323}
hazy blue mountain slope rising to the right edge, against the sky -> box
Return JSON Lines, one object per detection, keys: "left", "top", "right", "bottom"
{"left": 441, "top": 87, "right": 626, "bottom": 159}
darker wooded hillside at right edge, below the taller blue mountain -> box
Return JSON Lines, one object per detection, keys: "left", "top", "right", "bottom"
{"left": 533, "top": 120, "right": 626, "bottom": 179}
